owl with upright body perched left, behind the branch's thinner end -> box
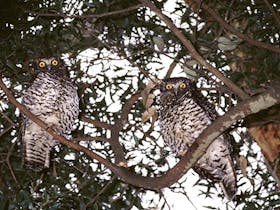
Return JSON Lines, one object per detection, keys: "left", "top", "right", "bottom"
{"left": 21, "top": 58, "right": 79, "bottom": 171}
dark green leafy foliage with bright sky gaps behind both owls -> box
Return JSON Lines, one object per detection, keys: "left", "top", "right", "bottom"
{"left": 0, "top": 0, "right": 280, "bottom": 209}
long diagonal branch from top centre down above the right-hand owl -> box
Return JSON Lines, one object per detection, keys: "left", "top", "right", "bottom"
{"left": 139, "top": 0, "right": 248, "bottom": 99}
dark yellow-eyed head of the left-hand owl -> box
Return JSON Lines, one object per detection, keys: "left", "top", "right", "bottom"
{"left": 35, "top": 57, "right": 68, "bottom": 76}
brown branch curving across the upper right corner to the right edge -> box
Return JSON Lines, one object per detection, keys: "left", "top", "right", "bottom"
{"left": 195, "top": 0, "right": 280, "bottom": 53}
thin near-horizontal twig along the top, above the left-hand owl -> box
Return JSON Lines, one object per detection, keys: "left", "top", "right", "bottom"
{"left": 26, "top": 4, "right": 142, "bottom": 19}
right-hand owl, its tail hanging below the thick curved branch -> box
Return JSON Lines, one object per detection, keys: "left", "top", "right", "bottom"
{"left": 159, "top": 77, "right": 237, "bottom": 200}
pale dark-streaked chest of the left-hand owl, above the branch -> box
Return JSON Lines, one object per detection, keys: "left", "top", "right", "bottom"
{"left": 23, "top": 73, "right": 79, "bottom": 130}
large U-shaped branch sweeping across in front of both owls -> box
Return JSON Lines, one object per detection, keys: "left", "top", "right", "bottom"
{"left": 0, "top": 77, "right": 280, "bottom": 189}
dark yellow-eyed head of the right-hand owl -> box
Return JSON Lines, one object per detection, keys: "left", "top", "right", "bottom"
{"left": 160, "top": 77, "right": 195, "bottom": 100}
